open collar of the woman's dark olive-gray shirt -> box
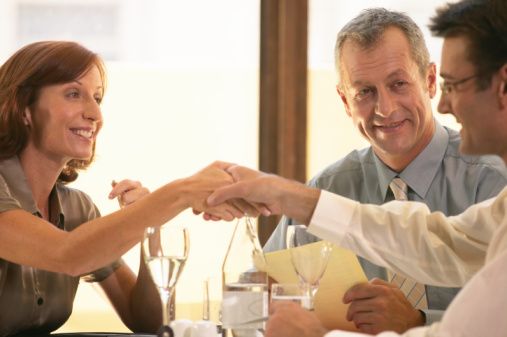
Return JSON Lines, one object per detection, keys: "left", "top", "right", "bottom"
{"left": 0, "top": 156, "right": 64, "bottom": 228}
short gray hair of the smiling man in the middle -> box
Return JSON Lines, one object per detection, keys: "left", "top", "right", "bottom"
{"left": 335, "top": 8, "right": 430, "bottom": 83}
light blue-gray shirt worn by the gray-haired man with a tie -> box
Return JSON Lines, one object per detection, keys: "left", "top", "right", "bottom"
{"left": 264, "top": 122, "right": 507, "bottom": 325}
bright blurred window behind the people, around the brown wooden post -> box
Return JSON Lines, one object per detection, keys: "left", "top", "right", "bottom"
{"left": 0, "top": 0, "right": 456, "bottom": 332}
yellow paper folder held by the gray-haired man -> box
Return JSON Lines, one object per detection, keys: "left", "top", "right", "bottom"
{"left": 265, "top": 242, "right": 368, "bottom": 331}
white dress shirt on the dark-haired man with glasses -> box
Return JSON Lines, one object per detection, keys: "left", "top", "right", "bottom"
{"left": 309, "top": 188, "right": 507, "bottom": 337}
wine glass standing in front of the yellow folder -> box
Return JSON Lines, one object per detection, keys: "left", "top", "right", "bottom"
{"left": 286, "top": 225, "right": 332, "bottom": 310}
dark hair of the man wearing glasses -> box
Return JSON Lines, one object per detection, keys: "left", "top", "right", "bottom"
{"left": 429, "top": 0, "right": 507, "bottom": 89}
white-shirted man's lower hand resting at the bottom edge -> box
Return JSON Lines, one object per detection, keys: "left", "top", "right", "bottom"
{"left": 264, "top": 301, "right": 327, "bottom": 337}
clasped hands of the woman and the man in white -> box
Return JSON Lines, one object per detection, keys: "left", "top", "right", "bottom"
{"left": 184, "top": 162, "right": 320, "bottom": 223}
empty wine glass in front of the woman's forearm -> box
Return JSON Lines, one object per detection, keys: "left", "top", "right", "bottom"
{"left": 142, "top": 224, "right": 190, "bottom": 337}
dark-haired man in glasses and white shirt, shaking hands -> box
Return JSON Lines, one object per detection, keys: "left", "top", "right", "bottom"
{"left": 208, "top": 0, "right": 507, "bottom": 337}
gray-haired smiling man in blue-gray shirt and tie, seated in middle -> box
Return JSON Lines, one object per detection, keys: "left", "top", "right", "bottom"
{"left": 264, "top": 8, "right": 507, "bottom": 333}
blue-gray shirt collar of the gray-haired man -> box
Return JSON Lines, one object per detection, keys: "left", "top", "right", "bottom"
{"left": 372, "top": 120, "right": 449, "bottom": 200}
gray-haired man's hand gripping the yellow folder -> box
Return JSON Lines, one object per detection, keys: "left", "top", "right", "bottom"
{"left": 343, "top": 279, "right": 424, "bottom": 334}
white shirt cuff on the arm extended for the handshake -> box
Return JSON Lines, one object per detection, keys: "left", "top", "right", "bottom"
{"left": 308, "top": 190, "right": 359, "bottom": 244}
